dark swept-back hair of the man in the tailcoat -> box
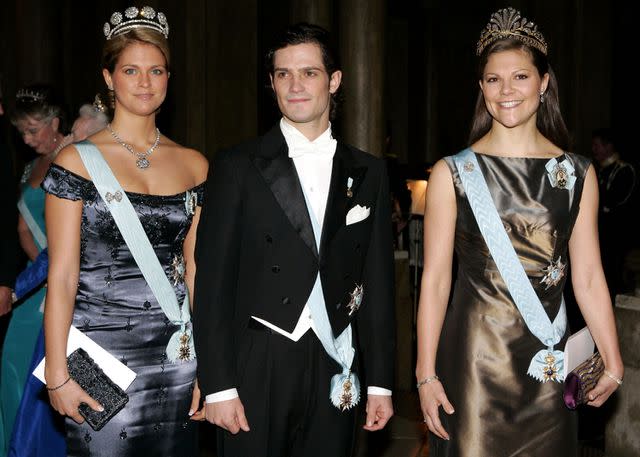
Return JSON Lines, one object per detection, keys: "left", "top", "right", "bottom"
{"left": 265, "top": 22, "right": 341, "bottom": 119}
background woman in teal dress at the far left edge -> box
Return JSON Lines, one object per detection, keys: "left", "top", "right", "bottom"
{"left": 0, "top": 85, "right": 65, "bottom": 453}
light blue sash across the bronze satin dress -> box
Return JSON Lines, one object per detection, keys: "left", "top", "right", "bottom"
{"left": 453, "top": 149, "right": 567, "bottom": 382}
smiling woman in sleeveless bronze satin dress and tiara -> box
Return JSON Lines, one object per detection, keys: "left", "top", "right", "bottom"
{"left": 416, "top": 8, "right": 624, "bottom": 457}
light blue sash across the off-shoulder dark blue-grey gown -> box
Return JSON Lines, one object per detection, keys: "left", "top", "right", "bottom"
{"left": 75, "top": 141, "right": 195, "bottom": 362}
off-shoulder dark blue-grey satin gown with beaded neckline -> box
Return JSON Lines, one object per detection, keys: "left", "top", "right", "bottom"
{"left": 42, "top": 164, "right": 203, "bottom": 457}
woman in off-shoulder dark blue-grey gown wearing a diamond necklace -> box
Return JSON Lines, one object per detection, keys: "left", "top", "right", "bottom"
{"left": 43, "top": 7, "right": 208, "bottom": 457}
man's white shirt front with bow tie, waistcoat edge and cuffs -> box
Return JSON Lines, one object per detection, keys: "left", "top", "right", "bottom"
{"left": 206, "top": 118, "right": 391, "bottom": 403}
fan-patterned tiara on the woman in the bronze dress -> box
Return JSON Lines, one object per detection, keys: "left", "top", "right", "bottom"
{"left": 476, "top": 8, "right": 547, "bottom": 55}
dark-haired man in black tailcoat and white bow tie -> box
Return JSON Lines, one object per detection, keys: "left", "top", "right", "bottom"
{"left": 194, "top": 24, "right": 395, "bottom": 457}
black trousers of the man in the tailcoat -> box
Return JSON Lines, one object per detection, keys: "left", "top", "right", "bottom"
{"left": 217, "top": 322, "right": 366, "bottom": 457}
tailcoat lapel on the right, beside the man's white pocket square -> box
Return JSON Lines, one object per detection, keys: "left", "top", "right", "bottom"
{"left": 320, "top": 142, "right": 367, "bottom": 254}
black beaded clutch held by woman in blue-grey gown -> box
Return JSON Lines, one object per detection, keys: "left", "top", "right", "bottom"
{"left": 67, "top": 348, "right": 129, "bottom": 431}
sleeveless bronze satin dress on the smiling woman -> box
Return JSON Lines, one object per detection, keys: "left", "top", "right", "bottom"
{"left": 429, "top": 154, "right": 590, "bottom": 457}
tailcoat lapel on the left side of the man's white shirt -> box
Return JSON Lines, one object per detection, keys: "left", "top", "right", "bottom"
{"left": 252, "top": 126, "right": 318, "bottom": 257}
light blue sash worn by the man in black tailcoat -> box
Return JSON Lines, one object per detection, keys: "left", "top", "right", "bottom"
{"left": 301, "top": 186, "right": 360, "bottom": 411}
